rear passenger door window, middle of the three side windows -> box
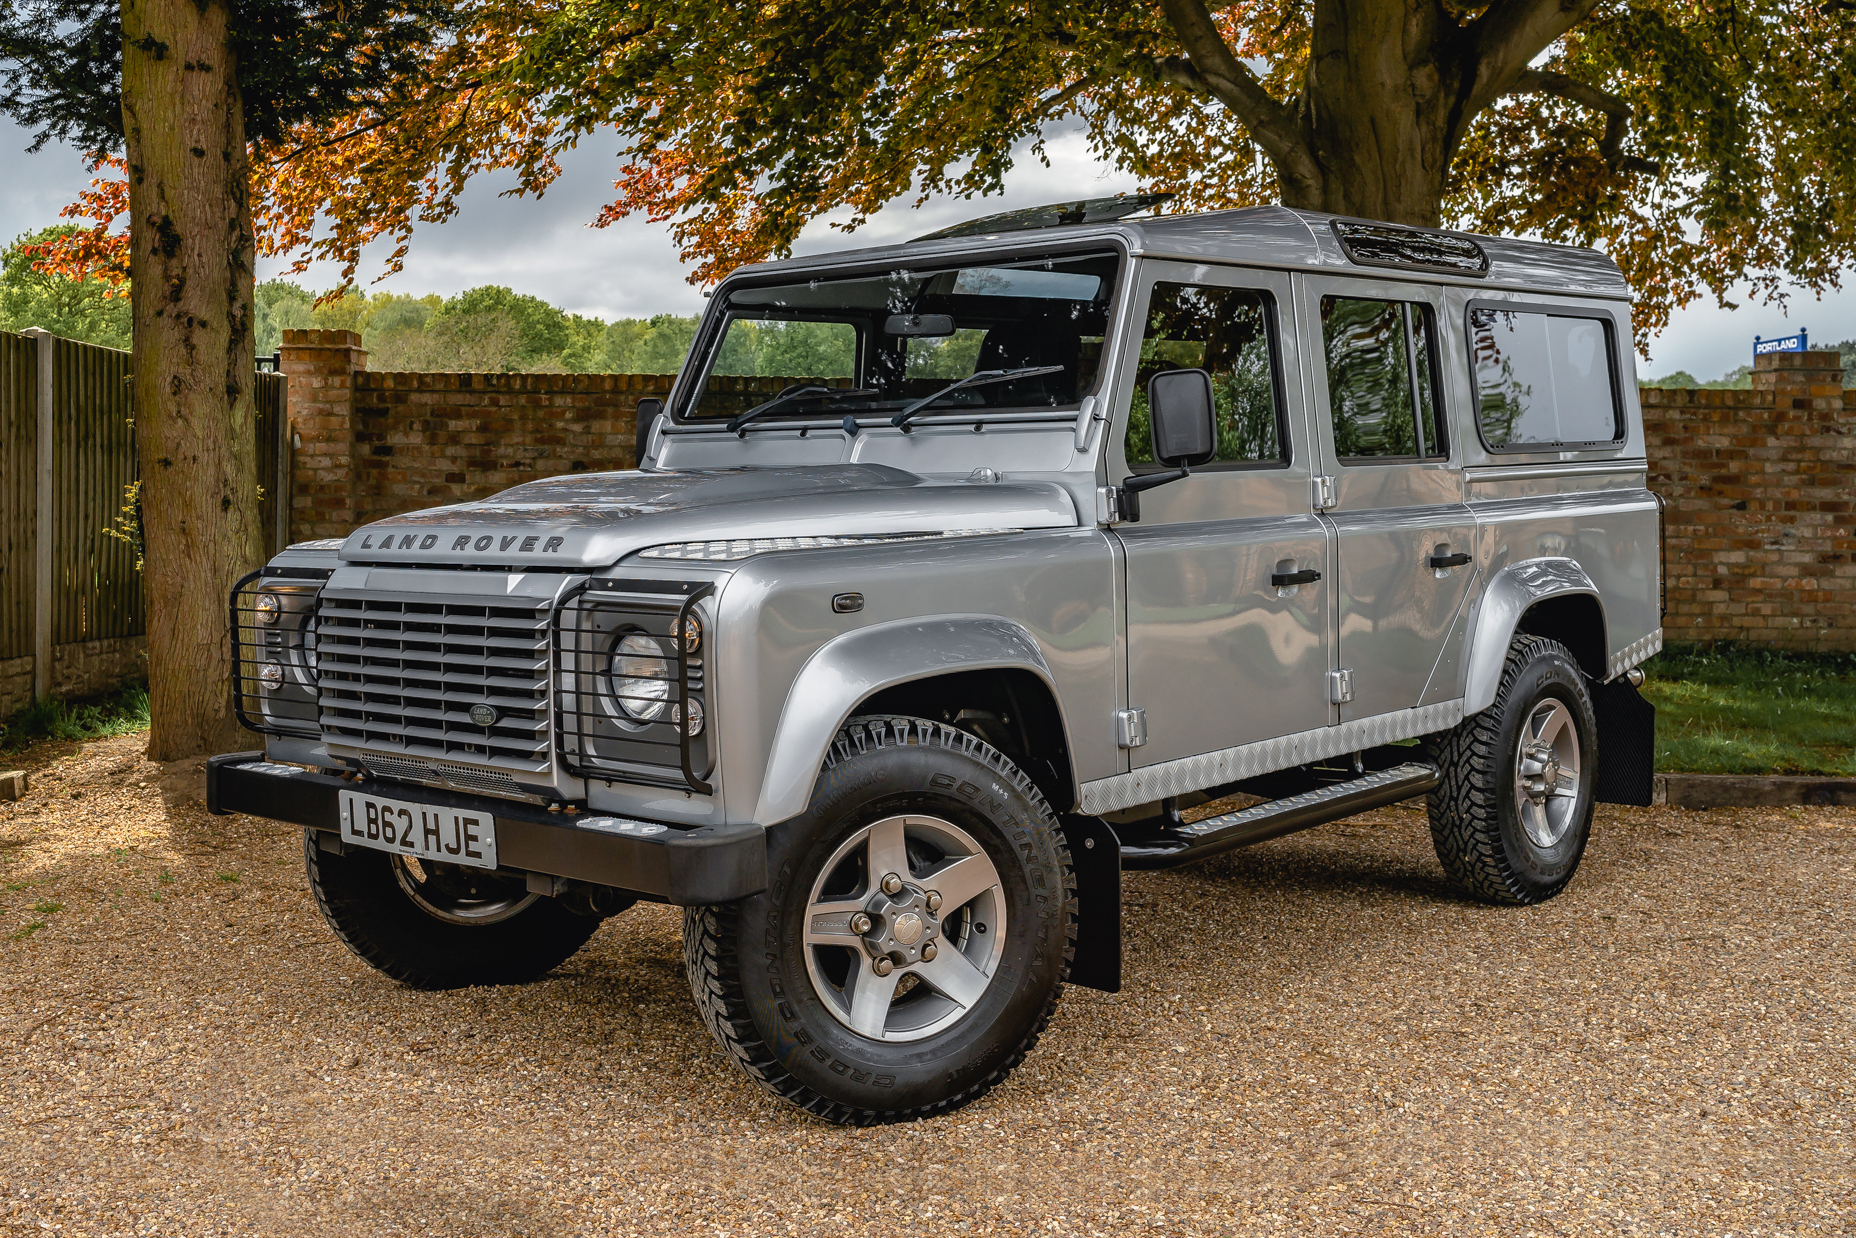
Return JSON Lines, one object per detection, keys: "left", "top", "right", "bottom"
{"left": 1321, "top": 297, "right": 1448, "bottom": 460}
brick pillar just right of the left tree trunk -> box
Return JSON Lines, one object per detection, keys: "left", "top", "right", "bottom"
{"left": 278, "top": 330, "right": 367, "bottom": 542}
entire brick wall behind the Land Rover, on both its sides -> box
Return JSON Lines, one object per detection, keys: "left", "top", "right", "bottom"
{"left": 280, "top": 330, "right": 1856, "bottom": 650}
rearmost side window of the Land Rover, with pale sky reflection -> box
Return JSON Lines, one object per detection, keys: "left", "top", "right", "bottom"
{"left": 1470, "top": 304, "right": 1620, "bottom": 451}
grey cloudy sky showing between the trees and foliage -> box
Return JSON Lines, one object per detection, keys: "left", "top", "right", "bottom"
{"left": 0, "top": 121, "right": 1856, "bottom": 379}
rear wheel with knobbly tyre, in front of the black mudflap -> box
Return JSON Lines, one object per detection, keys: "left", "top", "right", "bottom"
{"left": 1429, "top": 635, "right": 1598, "bottom": 906}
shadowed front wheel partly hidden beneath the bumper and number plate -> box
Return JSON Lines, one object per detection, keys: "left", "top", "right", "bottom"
{"left": 303, "top": 830, "right": 599, "bottom": 989}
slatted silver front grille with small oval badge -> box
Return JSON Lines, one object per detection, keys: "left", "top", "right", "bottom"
{"left": 317, "top": 590, "right": 551, "bottom": 775}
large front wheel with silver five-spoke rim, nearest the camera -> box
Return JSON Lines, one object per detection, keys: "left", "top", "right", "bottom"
{"left": 683, "top": 718, "right": 1076, "bottom": 1125}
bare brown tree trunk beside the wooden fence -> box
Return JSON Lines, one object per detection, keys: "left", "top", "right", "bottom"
{"left": 122, "top": 0, "right": 264, "bottom": 761}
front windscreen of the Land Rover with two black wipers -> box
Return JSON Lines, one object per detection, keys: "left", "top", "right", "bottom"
{"left": 683, "top": 254, "right": 1121, "bottom": 421}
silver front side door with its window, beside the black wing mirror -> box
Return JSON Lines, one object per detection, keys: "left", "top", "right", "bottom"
{"left": 1108, "top": 262, "right": 1331, "bottom": 768}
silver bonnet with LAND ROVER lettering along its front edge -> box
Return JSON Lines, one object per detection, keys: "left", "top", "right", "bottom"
{"left": 342, "top": 464, "right": 1076, "bottom": 570}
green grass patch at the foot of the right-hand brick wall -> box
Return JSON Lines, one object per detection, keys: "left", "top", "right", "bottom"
{"left": 1643, "top": 644, "right": 1856, "bottom": 776}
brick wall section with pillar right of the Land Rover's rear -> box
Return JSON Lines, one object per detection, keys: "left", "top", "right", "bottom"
{"left": 1641, "top": 353, "right": 1856, "bottom": 650}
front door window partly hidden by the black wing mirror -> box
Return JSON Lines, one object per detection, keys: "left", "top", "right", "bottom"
{"left": 1123, "top": 284, "right": 1288, "bottom": 471}
